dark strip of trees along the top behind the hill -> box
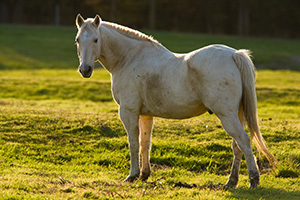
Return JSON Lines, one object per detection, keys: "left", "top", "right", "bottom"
{"left": 0, "top": 0, "right": 300, "bottom": 38}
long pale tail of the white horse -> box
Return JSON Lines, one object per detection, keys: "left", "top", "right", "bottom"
{"left": 232, "top": 49, "right": 276, "bottom": 168}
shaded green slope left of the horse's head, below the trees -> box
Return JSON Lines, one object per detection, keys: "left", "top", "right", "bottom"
{"left": 0, "top": 25, "right": 77, "bottom": 69}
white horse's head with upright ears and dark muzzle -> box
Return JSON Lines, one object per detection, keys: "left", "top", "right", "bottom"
{"left": 76, "top": 14, "right": 101, "bottom": 78}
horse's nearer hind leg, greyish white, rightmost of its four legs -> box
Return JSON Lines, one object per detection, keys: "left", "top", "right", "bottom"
{"left": 219, "top": 114, "right": 259, "bottom": 188}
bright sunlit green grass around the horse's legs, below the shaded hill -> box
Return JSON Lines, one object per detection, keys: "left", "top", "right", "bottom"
{"left": 0, "top": 70, "right": 300, "bottom": 199}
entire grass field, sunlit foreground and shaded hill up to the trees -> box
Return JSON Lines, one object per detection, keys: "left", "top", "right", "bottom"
{"left": 0, "top": 25, "right": 300, "bottom": 199}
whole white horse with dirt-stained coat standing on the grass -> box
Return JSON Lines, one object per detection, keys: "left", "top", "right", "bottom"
{"left": 76, "top": 15, "right": 274, "bottom": 188}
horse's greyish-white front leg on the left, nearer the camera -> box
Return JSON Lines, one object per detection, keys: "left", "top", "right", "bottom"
{"left": 119, "top": 107, "right": 140, "bottom": 182}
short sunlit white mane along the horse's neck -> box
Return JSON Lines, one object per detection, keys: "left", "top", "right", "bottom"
{"left": 101, "top": 21, "right": 160, "bottom": 44}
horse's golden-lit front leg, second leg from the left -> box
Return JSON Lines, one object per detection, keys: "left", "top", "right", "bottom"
{"left": 139, "top": 115, "right": 153, "bottom": 181}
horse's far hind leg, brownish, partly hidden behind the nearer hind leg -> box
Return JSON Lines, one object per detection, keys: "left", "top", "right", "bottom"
{"left": 224, "top": 106, "right": 245, "bottom": 189}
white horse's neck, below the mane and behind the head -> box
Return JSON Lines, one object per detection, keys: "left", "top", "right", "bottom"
{"left": 99, "top": 26, "right": 145, "bottom": 73}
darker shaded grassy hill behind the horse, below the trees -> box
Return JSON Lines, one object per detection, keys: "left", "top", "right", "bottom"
{"left": 0, "top": 24, "right": 300, "bottom": 70}
